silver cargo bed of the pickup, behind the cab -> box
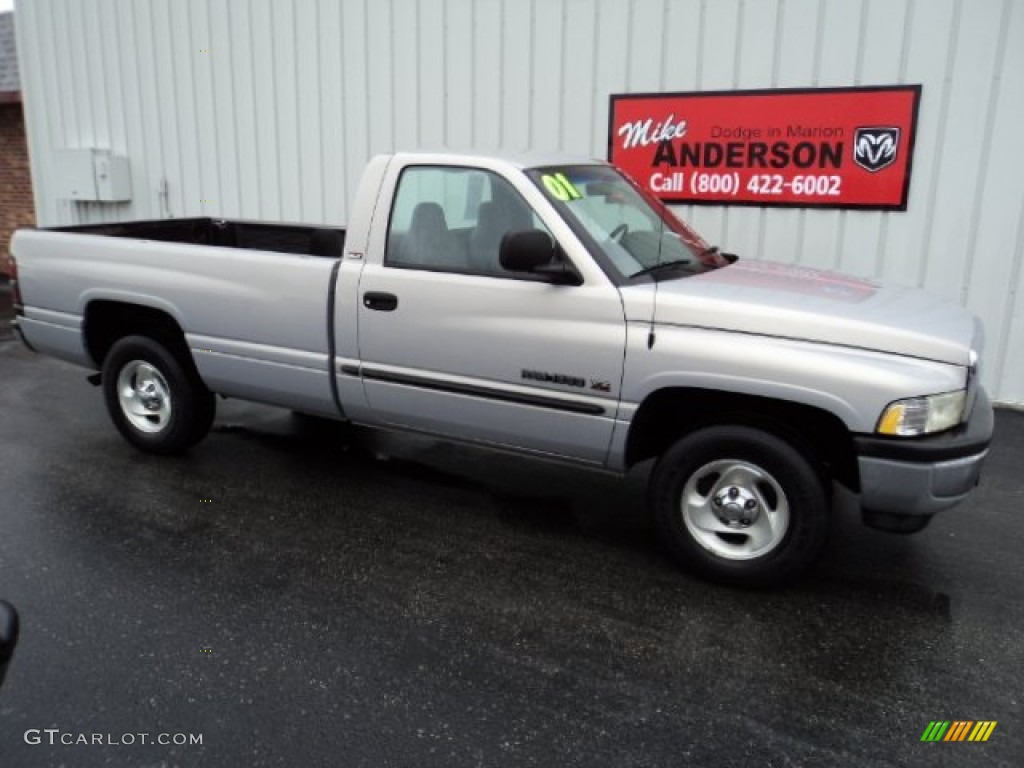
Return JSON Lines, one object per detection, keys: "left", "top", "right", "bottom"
{"left": 13, "top": 218, "right": 345, "bottom": 416}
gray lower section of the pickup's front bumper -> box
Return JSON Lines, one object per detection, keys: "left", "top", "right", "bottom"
{"left": 858, "top": 451, "right": 988, "bottom": 515}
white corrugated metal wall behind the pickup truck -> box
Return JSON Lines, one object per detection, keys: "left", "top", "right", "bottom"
{"left": 16, "top": 0, "right": 1024, "bottom": 403}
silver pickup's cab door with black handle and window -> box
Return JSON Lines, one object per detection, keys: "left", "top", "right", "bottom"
{"left": 358, "top": 166, "right": 626, "bottom": 463}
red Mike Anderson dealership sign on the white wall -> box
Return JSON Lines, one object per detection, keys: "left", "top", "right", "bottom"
{"left": 608, "top": 85, "right": 921, "bottom": 211}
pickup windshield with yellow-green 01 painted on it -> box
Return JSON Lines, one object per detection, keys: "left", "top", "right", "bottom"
{"left": 527, "top": 165, "right": 729, "bottom": 278}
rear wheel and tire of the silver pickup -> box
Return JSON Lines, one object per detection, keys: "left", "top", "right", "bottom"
{"left": 102, "top": 336, "right": 217, "bottom": 456}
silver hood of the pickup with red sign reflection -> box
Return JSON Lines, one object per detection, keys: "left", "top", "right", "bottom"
{"left": 627, "top": 260, "right": 975, "bottom": 366}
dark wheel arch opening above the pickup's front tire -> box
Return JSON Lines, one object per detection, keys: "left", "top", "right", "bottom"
{"left": 625, "top": 387, "right": 860, "bottom": 492}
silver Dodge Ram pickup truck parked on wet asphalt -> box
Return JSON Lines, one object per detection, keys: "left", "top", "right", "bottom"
{"left": 11, "top": 154, "right": 992, "bottom": 586}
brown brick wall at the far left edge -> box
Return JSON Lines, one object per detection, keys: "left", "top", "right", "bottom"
{"left": 0, "top": 103, "right": 36, "bottom": 273}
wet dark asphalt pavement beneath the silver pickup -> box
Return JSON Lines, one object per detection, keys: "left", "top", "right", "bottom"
{"left": 0, "top": 327, "right": 1024, "bottom": 768}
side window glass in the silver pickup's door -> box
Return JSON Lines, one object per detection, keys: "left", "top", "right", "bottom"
{"left": 384, "top": 166, "right": 550, "bottom": 278}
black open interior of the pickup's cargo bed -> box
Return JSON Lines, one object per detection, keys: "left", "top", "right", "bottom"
{"left": 48, "top": 216, "right": 345, "bottom": 258}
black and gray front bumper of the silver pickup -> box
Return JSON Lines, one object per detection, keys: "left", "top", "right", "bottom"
{"left": 854, "top": 389, "right": 994, "bottom": 516}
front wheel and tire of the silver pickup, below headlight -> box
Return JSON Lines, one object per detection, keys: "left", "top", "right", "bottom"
{"left": 650, "top": 426, "right": 830, "bottom": 587}
